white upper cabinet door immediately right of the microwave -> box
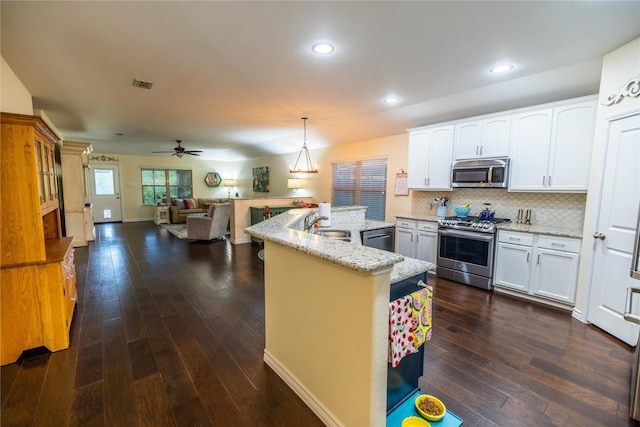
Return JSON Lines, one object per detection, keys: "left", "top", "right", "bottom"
{"left": 509, "top": 108, "right": 552, "bottom": 191}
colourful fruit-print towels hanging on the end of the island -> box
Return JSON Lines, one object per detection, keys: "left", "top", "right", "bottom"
{"left": 389, "top": 282, "right": 433, "bottom": 368}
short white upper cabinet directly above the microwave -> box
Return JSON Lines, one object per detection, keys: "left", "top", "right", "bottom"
{"left": 455, "top": 115, "right": 511, "bottom": 160}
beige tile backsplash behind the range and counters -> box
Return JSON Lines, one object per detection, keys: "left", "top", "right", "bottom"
{"left": 411, "top": 188, "right": 587, "bottom": 229}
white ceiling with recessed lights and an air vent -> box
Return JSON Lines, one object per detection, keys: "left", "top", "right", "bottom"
{"left": 0, "top": 0, "right": 640, "bottom": 160}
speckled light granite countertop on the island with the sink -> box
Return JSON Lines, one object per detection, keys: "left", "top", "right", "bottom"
{"left": 245, "top": 206, "right": 436, "bottom": 283}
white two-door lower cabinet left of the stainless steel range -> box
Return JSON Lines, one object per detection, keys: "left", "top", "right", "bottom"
{"left": 395, "top": 218, "right": 438, "bottom": 270}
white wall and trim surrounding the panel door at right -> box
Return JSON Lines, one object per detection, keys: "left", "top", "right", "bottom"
{"left": 576, "top": 38, "right": 640, "bottom": 320}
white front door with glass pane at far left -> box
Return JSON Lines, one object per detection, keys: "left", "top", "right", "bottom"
{"left": 91, "top": 165, "right": 122, "bottom": 223}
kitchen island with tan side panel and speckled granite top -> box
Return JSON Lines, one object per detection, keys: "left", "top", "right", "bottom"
{"left": 246, "top": 206, "right": 435, "bottom": 426}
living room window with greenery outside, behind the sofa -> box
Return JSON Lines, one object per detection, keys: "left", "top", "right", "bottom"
{"left": 142, "top": 168, "right": 193, "bottom": 205}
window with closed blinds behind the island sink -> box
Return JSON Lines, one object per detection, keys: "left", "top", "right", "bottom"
{"left": 331, "top": 159, "right": 387, "bottom": 221}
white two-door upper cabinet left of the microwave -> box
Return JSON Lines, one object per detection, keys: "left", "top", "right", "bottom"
{"left": 408, "top": 125, "right": 454, "bottom": 190}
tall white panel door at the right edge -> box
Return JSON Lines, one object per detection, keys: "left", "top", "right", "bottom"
{"left": 588, "top": 113, "right": 640, "bottom": 345}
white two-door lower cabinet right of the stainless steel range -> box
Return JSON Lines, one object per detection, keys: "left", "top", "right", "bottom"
{"left": 494, "top": 230, "right": 581, "bottom": 305}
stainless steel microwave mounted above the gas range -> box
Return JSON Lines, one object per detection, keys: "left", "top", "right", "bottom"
{"left": 451, "top": 158, "right": 509, "bottom": 188}
